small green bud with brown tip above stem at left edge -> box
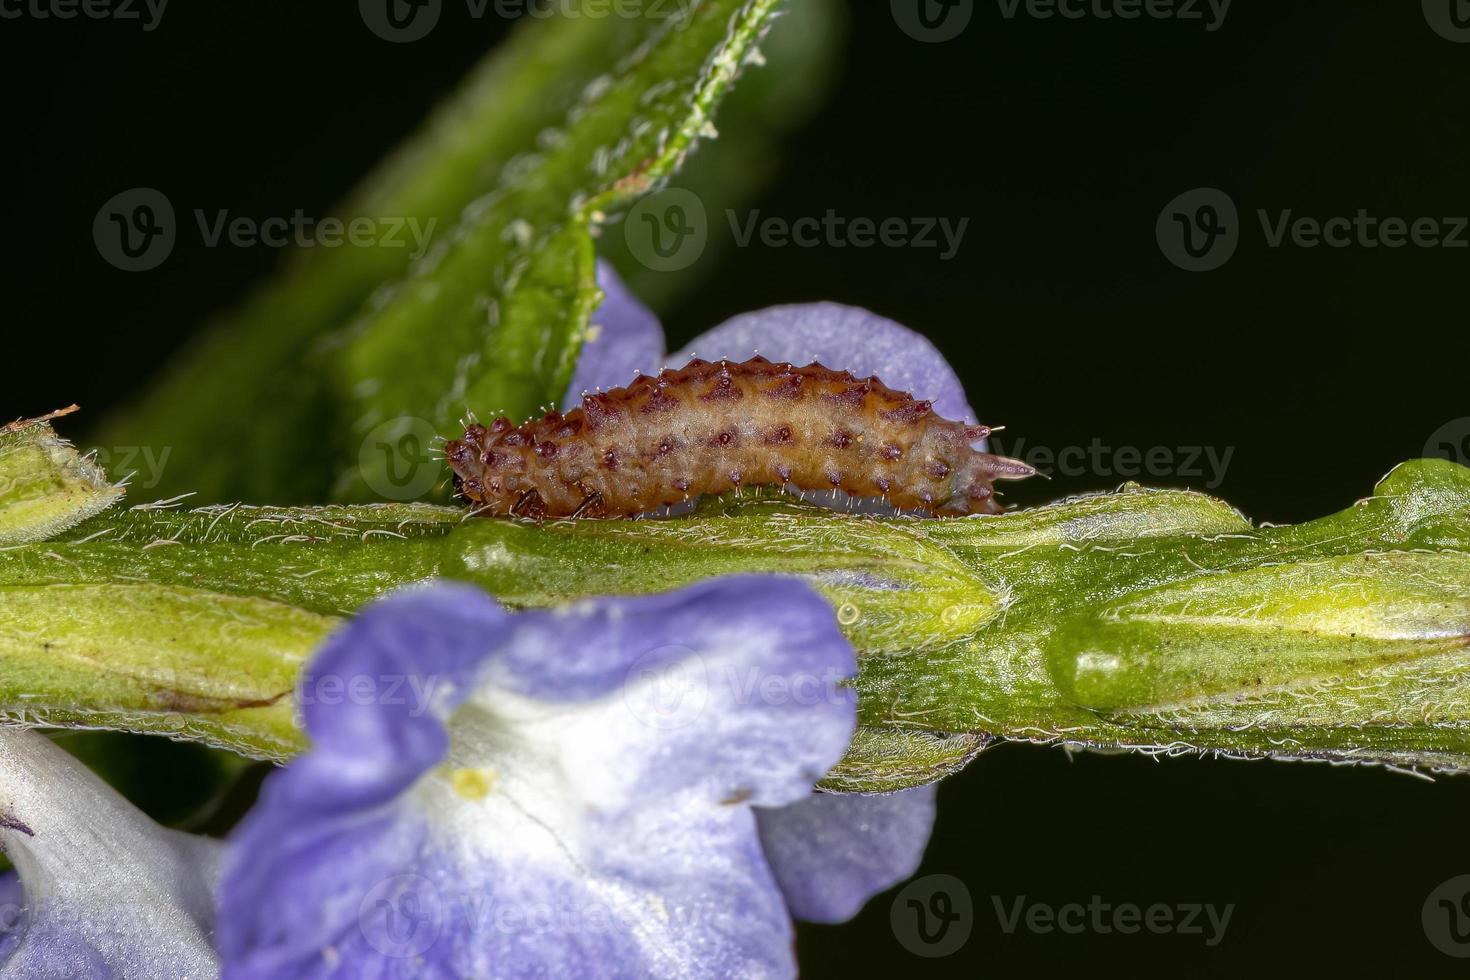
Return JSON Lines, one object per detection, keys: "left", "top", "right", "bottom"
{"left": 0, "top": 406, "right": 122, "bottom": 545}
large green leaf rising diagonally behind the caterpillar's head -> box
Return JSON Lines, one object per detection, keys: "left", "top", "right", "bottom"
{"left": 337, "top": 0, "right": 778, "bottom": 498}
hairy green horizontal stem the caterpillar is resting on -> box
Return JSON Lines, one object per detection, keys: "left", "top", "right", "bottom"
{"left": 0, "top": 461, "right": 1470, "bottom": 789}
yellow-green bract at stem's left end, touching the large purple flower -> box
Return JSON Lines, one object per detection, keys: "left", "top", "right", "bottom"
{"left": 0, "top": 582, "right": 330, "bottom": 757}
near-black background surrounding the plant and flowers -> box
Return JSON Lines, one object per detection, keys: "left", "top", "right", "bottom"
{"left": 0, "top": 0, "right": 1470, "bottom": 977}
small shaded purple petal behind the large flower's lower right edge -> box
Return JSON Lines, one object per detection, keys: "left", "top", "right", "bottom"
{"left": 756, "top": 785, "right": 936, "bottom": 923}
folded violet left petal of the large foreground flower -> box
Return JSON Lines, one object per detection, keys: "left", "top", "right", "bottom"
{"left": 210, "top": 588, "right": 509, "bottom": 977}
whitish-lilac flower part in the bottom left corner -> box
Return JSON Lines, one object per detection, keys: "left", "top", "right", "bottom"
{"left": 0, "top": 729, "right": 219, "bottom": 980}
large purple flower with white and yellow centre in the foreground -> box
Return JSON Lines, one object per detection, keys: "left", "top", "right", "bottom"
{"left": 221, "top": 576, "right": 856, "bottom": 977}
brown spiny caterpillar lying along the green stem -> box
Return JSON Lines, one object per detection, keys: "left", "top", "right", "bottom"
{"left": 445, "top": 357, "right": 1033, "bottom": 519}
